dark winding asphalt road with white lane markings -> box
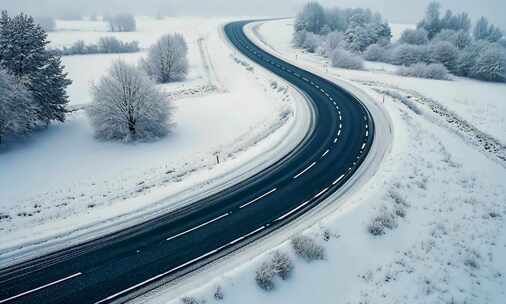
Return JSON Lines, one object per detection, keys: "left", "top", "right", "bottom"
{"left": 0, "top": 22, "right": 374, "bottom": 304}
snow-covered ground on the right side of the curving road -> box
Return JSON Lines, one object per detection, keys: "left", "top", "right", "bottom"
{"left": 138, "top": 20, "right": 506, "bottom": 304}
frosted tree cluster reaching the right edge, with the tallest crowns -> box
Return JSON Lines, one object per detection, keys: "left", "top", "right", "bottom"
{"left": 364, "top": 2, "right": 506, "bottom": 82}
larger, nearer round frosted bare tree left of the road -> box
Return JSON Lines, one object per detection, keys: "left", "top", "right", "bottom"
{"left": 87, "top": 61, "right": 171, "bottom": 142}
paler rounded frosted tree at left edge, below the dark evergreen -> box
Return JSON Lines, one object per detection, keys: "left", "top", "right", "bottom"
{"left": 0, "top": 69, "right": 35, "bottom": 144}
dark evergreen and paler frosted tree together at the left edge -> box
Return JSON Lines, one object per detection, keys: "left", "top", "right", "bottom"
{"left": 0, "top": 11, "right": 71, "bottom": 143}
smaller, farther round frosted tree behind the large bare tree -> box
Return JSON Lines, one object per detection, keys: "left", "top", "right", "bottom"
{"left": 141, "top": 34, "right": 188, "bottom": 83}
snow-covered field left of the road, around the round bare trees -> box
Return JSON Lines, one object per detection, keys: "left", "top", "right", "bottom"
{"left": 0, "top": 18, "right": 306, "bottom": 263}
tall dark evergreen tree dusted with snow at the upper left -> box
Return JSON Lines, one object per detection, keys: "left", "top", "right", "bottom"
{"left": 0, "top": 11, "right": 71, "bottom": 125}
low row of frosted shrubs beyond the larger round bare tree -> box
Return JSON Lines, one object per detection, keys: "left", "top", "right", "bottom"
{"left": 53, "top": 36, "right": 140, "bottom": 56}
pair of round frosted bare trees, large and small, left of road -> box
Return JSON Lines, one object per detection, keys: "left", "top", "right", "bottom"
{"left": 87, "top": 34, "right": 188, "bottom": 142}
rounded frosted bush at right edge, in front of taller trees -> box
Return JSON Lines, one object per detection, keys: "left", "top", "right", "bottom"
{"left": 470, "top": 46, "right": 506, "bottom": 82}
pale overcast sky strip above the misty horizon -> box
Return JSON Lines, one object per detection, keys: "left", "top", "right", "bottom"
{"left": 0, "top": 0, "right": 506, "bottom": 29}
